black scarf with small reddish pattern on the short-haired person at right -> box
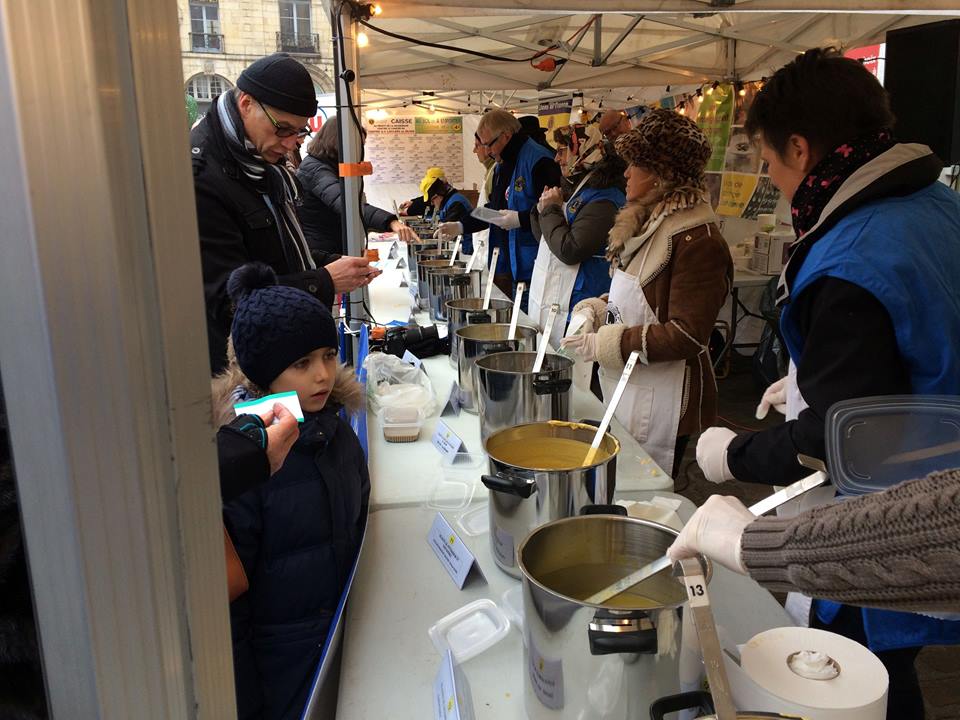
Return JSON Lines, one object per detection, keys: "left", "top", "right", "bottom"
{"left": 790, "top": 129, "right": 894, "bottom": 239}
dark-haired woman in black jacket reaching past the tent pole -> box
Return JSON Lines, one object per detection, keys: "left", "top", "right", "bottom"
{"left": 297, "top": 117, "right": 417, "bottom": 253}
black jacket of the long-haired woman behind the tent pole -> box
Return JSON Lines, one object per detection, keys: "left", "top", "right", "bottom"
{"left": 297, "top": 155, "right": 397, "bottom": 253}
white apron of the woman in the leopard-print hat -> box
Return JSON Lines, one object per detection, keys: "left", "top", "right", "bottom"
{"left": 600, "top": 242, "right": 686, "bottom": 475}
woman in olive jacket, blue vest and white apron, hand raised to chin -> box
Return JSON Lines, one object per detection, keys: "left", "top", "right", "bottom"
{"left": 527, "top": 125, "right": 627, "bottom": 347}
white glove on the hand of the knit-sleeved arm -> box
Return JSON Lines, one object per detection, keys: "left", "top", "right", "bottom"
{"left": 667, "top": 495, "right": 756, "bottom": 575}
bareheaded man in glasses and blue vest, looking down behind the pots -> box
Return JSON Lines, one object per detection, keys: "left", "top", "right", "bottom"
{"left": 439, "top": 109, "right": 561, "bottom": 308}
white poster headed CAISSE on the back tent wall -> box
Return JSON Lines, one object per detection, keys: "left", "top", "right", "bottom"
{"left": 364, "top": 115, "right": 463, "bottom": 187}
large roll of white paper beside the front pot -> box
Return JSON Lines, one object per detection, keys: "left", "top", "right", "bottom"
{"left": 726, "top": 627, "right": 888, "bottom": 720}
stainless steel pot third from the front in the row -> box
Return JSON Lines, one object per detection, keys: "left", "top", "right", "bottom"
{"left": 477, "top": 352, "right": 573, "bottom": 440}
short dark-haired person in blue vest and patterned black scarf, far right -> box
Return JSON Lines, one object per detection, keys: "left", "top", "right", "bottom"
{"left": 697, "top": 49, "right": 960, "bottom": 718}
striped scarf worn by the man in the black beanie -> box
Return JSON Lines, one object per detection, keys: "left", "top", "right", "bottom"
{"left": 210, "top": 90, "right": 316, "bottom": 270}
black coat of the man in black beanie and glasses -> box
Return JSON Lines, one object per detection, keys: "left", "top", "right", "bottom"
{"left": 190, "top": 112, "right": 338, "bottom": 375}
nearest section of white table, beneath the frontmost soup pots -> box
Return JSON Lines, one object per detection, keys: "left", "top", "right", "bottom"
{"left": 337, "top": 492, "right": 792, "bottom": 720}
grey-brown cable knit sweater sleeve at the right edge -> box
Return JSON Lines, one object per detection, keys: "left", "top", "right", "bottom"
{"left": 741, "top": 470, "right": 960, "bottom": 612}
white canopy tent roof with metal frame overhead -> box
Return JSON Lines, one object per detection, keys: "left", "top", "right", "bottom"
{"left": 358, "top": 0, "right": 960, "bottom": 112}
